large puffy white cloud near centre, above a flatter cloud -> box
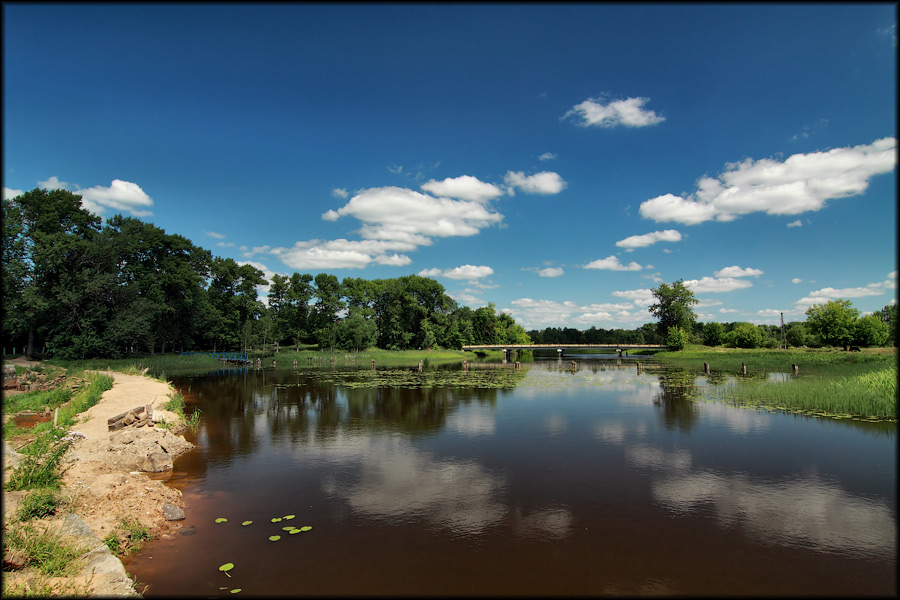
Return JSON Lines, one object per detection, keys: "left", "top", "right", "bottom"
{"left": 322, "top": 186, "right": 503, "bottom": 246}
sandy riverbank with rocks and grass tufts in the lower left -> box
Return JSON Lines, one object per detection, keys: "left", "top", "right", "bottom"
{"left": 3, "top": 364, "right": 191, "bottom": 597}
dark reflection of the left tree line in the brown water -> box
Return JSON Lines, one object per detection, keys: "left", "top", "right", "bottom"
{"left": 173, "top": 368, "right": 524, "bottom": 472}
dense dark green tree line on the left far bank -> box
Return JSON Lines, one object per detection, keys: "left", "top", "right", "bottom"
{"left": 2, "top": 189, "right": 529, "bottom": 359}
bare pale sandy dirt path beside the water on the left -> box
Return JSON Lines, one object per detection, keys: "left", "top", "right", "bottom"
{"left": 3, "top": 366, "right": 190, "bottom": 596}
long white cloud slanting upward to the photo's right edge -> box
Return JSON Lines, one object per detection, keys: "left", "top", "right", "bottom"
{"left": 640, "top": 138, "right": 897, "bottom": 225}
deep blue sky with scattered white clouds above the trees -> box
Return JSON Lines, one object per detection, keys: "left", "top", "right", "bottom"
{"left": 3, "top": 3, "right": 897, "bottom": 329}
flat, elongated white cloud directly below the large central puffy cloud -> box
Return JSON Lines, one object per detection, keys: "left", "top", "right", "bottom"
{"left": 268, "top": 239, "right": 417, "bottom": 270}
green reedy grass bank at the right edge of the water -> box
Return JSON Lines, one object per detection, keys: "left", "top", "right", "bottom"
{"left": 656, "top": 346, "right": 898, "bottom": 421}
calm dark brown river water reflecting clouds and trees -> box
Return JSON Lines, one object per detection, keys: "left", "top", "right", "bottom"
{"left": 125, "top": 359, "right": 897, "bottom": 598}
